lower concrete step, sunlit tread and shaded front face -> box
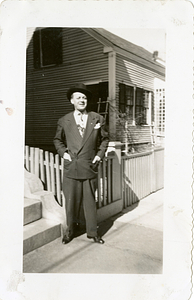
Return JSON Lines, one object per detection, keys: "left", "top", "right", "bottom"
{"left": 23, "top": 218, "right": 61, "bottom": 254}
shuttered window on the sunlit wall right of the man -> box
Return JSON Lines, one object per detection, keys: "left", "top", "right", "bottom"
{"left": 119, "top": 83, "right": 154, "bottom": 125}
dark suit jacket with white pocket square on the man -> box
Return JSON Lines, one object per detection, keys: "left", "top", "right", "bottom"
{"left": 53, "top": 112, "right": 109, "bottom": 179}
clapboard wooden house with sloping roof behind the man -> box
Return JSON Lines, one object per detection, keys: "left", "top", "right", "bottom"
{"left": 25, "top": 27, "right": 165, "bottom": 151}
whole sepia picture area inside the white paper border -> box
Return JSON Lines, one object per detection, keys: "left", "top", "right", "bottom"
{"left": 23, "top": 27, "right": 165, "bottom": 274}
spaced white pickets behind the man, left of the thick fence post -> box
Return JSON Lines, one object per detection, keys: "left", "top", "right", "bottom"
{"left": 24, "top": 146, "right": 112, "bottom": 208}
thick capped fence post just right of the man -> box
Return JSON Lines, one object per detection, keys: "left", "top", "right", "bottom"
{"left": 106, "top": 142, "right": 122, "bottom": 201}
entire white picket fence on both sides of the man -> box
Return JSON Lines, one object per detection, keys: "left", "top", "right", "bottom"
{"left": 24, "top": 146, "right": 164, "bottom": 208}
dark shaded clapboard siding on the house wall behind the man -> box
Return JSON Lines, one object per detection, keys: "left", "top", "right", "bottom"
{"left": 26, "top": 28, "right": 108, "bottom": 150}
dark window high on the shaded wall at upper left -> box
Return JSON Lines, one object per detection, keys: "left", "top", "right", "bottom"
{"left": 33, "top": 27, "right": 62, "bottom": 69}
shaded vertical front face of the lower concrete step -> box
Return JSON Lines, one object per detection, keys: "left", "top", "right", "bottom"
{"left": 23, "top": 224, "right": 61, "bottom": 254}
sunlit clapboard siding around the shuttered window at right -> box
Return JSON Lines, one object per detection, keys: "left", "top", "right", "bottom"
{"left": 116, "top": 54, "right": 164, "bottom": 143}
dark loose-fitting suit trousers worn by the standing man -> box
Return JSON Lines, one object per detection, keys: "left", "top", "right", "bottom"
{"left": 63, "top": 176, "right": 97, "bottom": 237}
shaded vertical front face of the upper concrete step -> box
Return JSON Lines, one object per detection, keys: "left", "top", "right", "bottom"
{"left": 24, "top": 202, "right": 42, "bottom": 225}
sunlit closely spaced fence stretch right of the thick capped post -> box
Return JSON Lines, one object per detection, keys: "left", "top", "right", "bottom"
{"left": 121, "top": 147, "right": 164, "bottom": 207}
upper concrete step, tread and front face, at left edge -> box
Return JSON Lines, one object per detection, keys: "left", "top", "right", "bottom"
{"left": 23, "top": 198, "right": 42, "bottom": 225}
